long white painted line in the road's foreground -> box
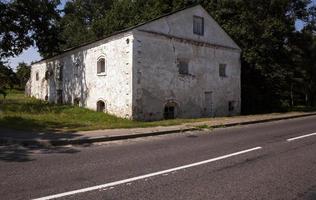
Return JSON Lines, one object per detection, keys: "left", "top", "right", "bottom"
{"left": 33, "top": 147, "right": 262, "bottom": 200}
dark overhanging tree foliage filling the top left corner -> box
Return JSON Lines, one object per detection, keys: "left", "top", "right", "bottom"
{"left": 0, "top": 0, "right": 60, "bottom": 60}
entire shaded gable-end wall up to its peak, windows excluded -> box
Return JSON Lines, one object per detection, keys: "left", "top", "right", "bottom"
{"left": 133, "top": 6, "right": 241, "bottom": 120}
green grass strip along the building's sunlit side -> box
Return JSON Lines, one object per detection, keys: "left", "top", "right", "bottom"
{"left": 0, "top": 90, "right": 211, "bottom": 132}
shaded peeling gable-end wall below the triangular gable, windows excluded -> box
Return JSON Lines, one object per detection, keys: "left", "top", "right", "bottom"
{"left": 133, "top": 31, "right": 240, "bottom": 120}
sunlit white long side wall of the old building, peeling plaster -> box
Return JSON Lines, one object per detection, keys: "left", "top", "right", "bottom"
{"left": 31, "top": 32, "right": 133, "bottom": 118}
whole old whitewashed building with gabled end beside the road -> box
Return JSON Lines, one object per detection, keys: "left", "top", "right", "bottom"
{"left": 28, "top": 5, "right": 241, "bottom": 120}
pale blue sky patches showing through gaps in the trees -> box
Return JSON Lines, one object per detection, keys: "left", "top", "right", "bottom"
{"left": 8, "top": 0, "right": 316, "bottom": 69}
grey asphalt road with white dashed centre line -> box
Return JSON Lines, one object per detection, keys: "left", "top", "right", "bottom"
{"left": 0, "top": 117, "right": 316, "bottom": 200}
